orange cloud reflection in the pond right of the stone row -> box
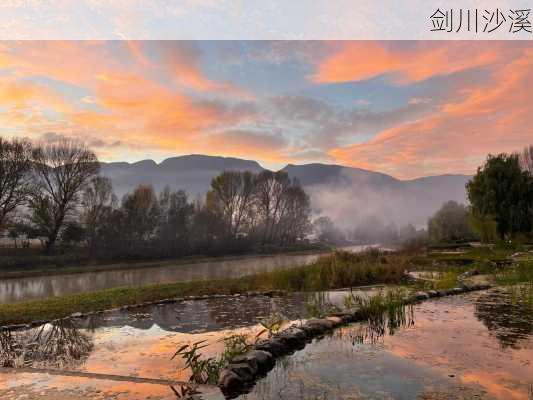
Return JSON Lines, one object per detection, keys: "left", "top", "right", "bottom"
{"left": 385, "top": 299, "right": 533, "bottom": 400}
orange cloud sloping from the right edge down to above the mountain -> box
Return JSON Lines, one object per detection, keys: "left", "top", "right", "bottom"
{"left": 329, "top": 44, "right": 533, "bottom": 178}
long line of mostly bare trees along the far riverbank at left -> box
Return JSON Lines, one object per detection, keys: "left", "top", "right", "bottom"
{"left": 0, "top": 138, "right": 311, "bottom": 258}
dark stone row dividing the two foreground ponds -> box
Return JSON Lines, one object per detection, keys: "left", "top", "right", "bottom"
{"left": 218, "top": 284, "right": 491, "bottom": 398}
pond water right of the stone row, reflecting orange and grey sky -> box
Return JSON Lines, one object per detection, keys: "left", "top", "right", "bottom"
{"left": 240, "top": 293, "right": 533, "bottom": 400}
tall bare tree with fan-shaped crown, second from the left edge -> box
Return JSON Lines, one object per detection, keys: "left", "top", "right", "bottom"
{"left": 30, "top": 140, "right": 100, "bottom": 252}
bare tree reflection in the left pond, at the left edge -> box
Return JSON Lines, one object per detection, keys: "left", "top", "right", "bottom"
{"left": 0, "top": 320, "right": 93, "bottom": 368}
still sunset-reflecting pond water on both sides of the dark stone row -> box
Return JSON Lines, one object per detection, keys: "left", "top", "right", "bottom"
{"left": 0, "top": 290, "right": 533, "bottom": 400}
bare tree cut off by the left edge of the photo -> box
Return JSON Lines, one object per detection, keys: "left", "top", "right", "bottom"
{"left": 0, "top": 137, "right": 32, "bottom": 228}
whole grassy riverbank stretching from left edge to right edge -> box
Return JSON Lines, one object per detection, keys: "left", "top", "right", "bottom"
{"left": 0, "top": 249, "right": 533, "bottom": 325}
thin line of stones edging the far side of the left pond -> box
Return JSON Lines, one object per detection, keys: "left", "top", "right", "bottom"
{"left": 0, "top": 290, "right": 286, "bottom": 332}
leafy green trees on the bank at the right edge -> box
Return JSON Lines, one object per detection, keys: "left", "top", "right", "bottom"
{"left": 428, "top": 145, "right": 533, "bottom": 243}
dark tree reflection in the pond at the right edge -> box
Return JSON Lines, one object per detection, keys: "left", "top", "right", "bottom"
{"left": 475, "top": 292, "right": 533, "bottom": 347}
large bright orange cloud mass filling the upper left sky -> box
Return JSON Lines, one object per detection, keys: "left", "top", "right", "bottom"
{"left": 0, "top": 41, "right": 251, "bottom": 152}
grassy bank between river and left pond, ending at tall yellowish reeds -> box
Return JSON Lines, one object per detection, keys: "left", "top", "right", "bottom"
{"left": 0, "top": 250, "right": 408, "bottom": 325}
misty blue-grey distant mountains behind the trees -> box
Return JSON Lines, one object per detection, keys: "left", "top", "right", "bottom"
{"left": 98, "top": 155, "right": 470, "bottom": 227}
